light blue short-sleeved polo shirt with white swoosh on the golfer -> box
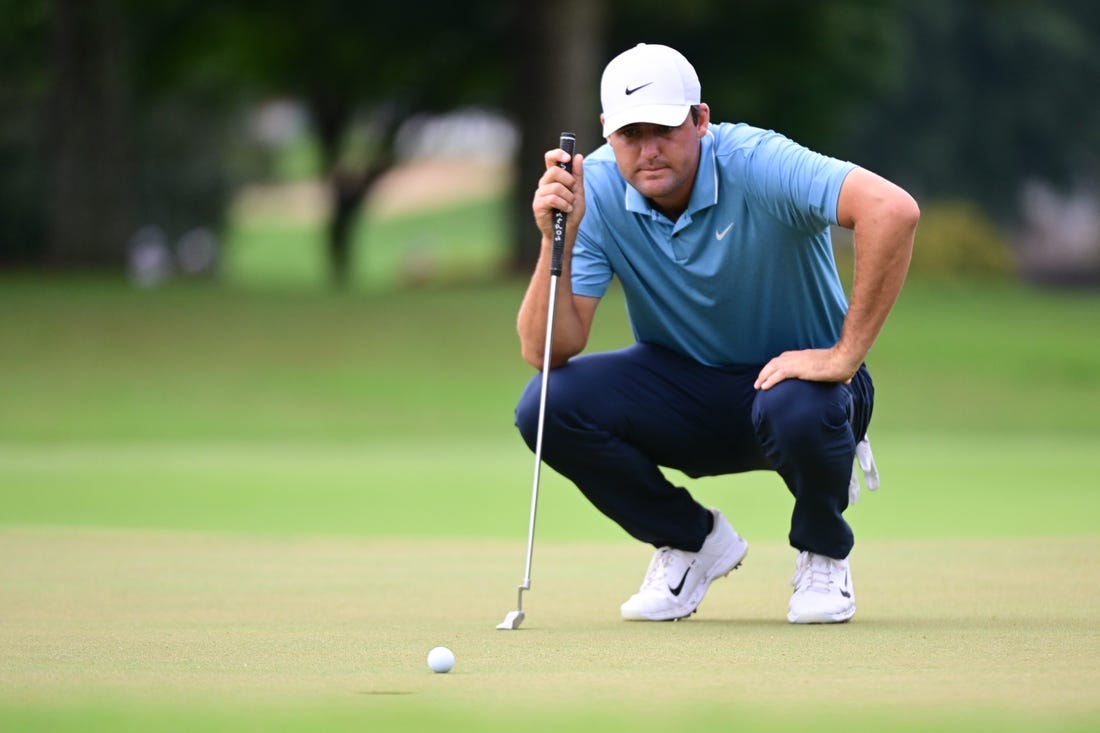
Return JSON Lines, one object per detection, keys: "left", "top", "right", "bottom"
{"left": 572, "top": 123, "right": 854, "bottom": 367}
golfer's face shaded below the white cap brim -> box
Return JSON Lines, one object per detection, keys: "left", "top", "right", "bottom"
{"left": 607, "top": 105, "right": 711, "bottom": 219}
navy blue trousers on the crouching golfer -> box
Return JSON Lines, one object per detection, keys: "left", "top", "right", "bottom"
{"left": 516, "top": 343, "right": 875, "bottom": 559}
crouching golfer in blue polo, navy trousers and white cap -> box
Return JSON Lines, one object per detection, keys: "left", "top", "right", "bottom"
{"left": 516, "top": 44, "right": 920, "bottom": 623}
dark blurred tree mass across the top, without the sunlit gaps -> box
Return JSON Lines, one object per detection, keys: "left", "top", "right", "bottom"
{"left": 0, "top": 0, "right": 1100, "bottom": 282}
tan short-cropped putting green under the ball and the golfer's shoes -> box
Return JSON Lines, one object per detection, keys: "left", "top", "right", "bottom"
{"left": 0, "top": 527, "right": 1100, "bottom": 730}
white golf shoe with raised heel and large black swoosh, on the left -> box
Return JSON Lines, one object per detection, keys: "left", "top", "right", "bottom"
{"left": 622, "top": 510, "right": 749, "bottom": 621}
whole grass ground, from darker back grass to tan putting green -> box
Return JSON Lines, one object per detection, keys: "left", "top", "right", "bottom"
{"left": 0, "top": 270, "right": 1100, "bottom": 731}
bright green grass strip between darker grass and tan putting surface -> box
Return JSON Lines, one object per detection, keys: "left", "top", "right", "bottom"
{"left": 0, "top": 431, "right": 1100, "bottom": 540}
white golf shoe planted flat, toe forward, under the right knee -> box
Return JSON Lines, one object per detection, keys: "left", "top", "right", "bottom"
{"left": 787, "top": 551, "right": 856, "bottom": 624}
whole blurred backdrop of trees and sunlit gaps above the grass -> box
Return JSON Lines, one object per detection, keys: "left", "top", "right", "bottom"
{"left": 0, "top": 0, "right": 1100, "bottom": 286}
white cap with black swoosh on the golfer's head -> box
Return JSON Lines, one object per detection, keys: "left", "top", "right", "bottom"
{"left": 600, "top": 43, "right": 701, "bottom": 138}
